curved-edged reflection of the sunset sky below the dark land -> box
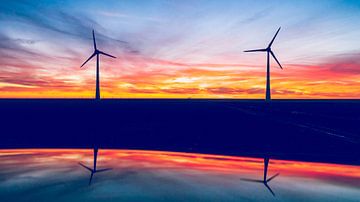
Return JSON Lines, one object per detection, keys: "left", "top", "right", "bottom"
{"left": 0, "top": 150, "right": 360, "bottom": 202}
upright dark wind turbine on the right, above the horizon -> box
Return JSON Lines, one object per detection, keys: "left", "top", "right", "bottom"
{"left": 244, "top": 27, "right": 282, "bottom": 101}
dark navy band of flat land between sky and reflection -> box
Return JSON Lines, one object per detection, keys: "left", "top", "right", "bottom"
{"left": 0, "top": 99, "right": 360, "bottom": 165}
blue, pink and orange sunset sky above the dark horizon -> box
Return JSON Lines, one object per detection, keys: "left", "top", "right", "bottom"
{"left": 0, "top": 0, "right": 360, "bottom": 99}
